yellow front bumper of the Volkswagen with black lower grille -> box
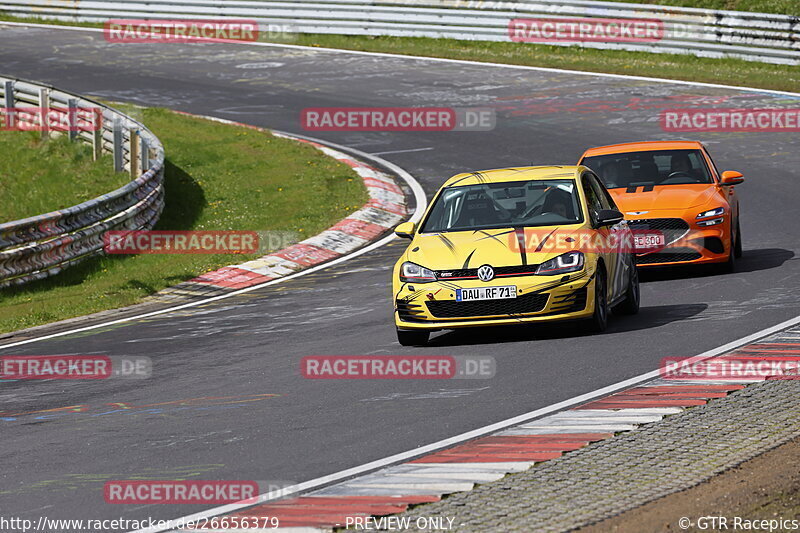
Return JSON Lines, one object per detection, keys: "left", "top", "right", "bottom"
{"left": 394, "top": 270, "right": 594, "bottom": 330}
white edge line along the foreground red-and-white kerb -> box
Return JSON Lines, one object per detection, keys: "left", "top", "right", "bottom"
{"left": 131, "top": 316, "right": 800, "bottom": 533}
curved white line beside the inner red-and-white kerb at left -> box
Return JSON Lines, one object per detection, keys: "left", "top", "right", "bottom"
{"left": 0, "top": 130, "right": 427, "bottom": 350}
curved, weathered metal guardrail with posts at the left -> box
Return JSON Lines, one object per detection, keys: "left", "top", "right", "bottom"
{"left": 0, "top": 76, "right": 164, "bottom": 287}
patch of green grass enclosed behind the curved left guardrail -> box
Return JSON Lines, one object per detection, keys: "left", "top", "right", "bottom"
{"left": 0, "top": 131, "right": 128, "bottom": 223}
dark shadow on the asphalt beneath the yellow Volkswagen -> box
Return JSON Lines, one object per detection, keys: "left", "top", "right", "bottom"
{"left": 428, "top": 304, "right": 708, "bottom": 347}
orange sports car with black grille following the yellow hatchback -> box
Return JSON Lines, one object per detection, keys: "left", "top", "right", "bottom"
{"left": 578, "top": 141, "right": 744, "bottom": 271}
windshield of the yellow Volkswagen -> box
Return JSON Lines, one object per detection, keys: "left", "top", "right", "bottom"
{"left": 421, "top": 179, "right": 583, "bottom": 233}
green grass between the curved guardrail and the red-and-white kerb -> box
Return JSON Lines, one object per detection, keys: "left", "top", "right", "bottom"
{"left": 0, "top": 106, "right": 367, "bottom": 332}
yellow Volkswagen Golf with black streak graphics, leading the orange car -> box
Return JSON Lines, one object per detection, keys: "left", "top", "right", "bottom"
{"left": 392, "top": 166, "right": 640, "bottom": 346}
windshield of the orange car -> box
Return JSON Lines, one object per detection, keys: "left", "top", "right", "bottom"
{"left": 581, "top": 150, "right": 714, "bottom": 189}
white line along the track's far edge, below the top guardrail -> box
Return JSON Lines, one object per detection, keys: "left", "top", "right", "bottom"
{"left": 0, "top": 21, "right": 800, "bottom": 97}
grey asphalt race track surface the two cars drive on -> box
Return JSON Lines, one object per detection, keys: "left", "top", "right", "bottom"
{"left": 0, "top": 23, "right": 800, "bottom": 519}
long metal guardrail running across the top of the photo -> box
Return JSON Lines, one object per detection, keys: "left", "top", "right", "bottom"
{"left": 0, "top": 0, "right": 800, "bottom": 65}
